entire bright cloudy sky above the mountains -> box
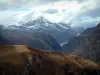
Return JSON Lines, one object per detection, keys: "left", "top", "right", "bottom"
{"left": 0, "top": 0, "right": 100, "bottom": 27}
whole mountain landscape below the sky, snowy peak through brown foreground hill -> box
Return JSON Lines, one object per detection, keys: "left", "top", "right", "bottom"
{"left": 0, "top": 17, "right": 100, "bottom": 75}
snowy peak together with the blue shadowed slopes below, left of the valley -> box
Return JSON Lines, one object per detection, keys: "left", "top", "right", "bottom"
{"left": 0, "top": 17, "right": 84, "bottom": 52}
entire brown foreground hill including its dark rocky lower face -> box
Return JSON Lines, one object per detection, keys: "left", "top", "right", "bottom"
{"left": 0, "top": 45, "right": 100, "bottom": 75}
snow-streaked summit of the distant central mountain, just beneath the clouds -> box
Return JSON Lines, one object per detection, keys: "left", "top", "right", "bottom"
{"left": 7, "top": 16, "right": 70, "bottom": 30}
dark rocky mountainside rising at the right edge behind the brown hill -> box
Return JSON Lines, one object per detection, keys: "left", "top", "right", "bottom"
{"left": 63, "top": 23, "right": 100, "bottom": 63}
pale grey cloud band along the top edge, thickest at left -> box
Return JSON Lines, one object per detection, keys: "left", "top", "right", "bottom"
{"left": 0, "top": 0, "right": 84, "bottom": 10}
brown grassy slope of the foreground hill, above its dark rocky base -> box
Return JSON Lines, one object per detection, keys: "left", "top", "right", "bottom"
{"left": 0, "top": 45, "right": 100, "bottom": 71}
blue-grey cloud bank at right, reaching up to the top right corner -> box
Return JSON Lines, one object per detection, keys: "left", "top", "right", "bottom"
{"left": 70, "top": 0, "right": 100, "bottom": 27}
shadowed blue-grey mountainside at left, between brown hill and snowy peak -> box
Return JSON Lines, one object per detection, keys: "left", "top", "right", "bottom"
{"left": 0, "top": 29, "right": 62, "bottom": 51}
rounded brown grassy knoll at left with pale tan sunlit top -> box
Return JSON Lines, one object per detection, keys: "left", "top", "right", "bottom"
{"left": 0, "top": 45, "right": 31, "bottom": 72}
